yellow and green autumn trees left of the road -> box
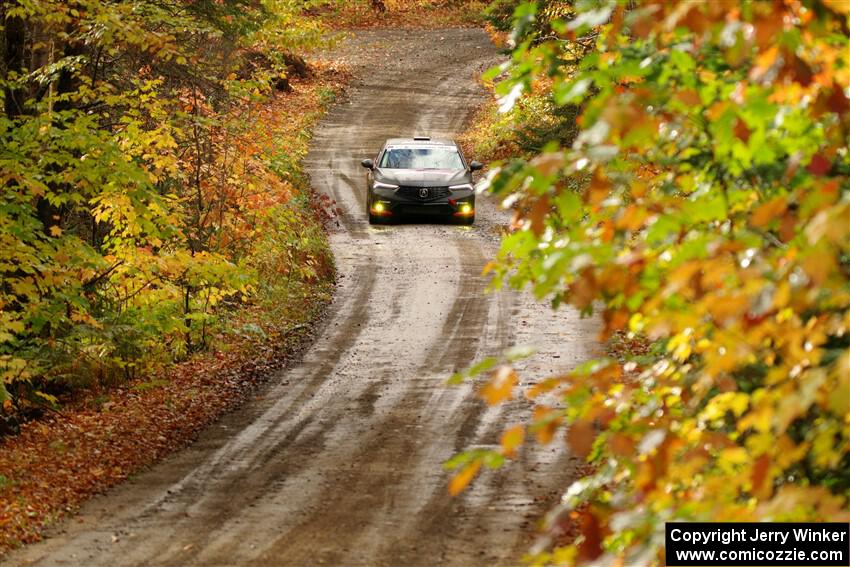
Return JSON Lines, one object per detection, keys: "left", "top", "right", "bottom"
{"left": 0, "top": 0, "right": 333, "bottom": 422}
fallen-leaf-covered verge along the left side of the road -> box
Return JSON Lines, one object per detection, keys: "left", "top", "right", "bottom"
{"left": 0, "top": 64, "right": 349, "bottom": 556}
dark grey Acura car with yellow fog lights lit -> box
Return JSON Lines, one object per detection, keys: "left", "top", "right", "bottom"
{"left": 361, "top": 136, "right": 483, "bottom": 224}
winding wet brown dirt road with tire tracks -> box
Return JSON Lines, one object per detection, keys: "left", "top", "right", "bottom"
{"left": 5, "top": 30, "right": 593, "bottom": 567}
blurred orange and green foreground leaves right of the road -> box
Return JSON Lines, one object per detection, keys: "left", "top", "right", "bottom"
{"left": 449, "top": 0, "right": 850, "bottom": 566}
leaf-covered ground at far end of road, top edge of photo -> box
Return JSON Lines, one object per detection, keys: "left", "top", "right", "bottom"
{"left": 320, "top": 0, "right": 488, "bottom": 29}
